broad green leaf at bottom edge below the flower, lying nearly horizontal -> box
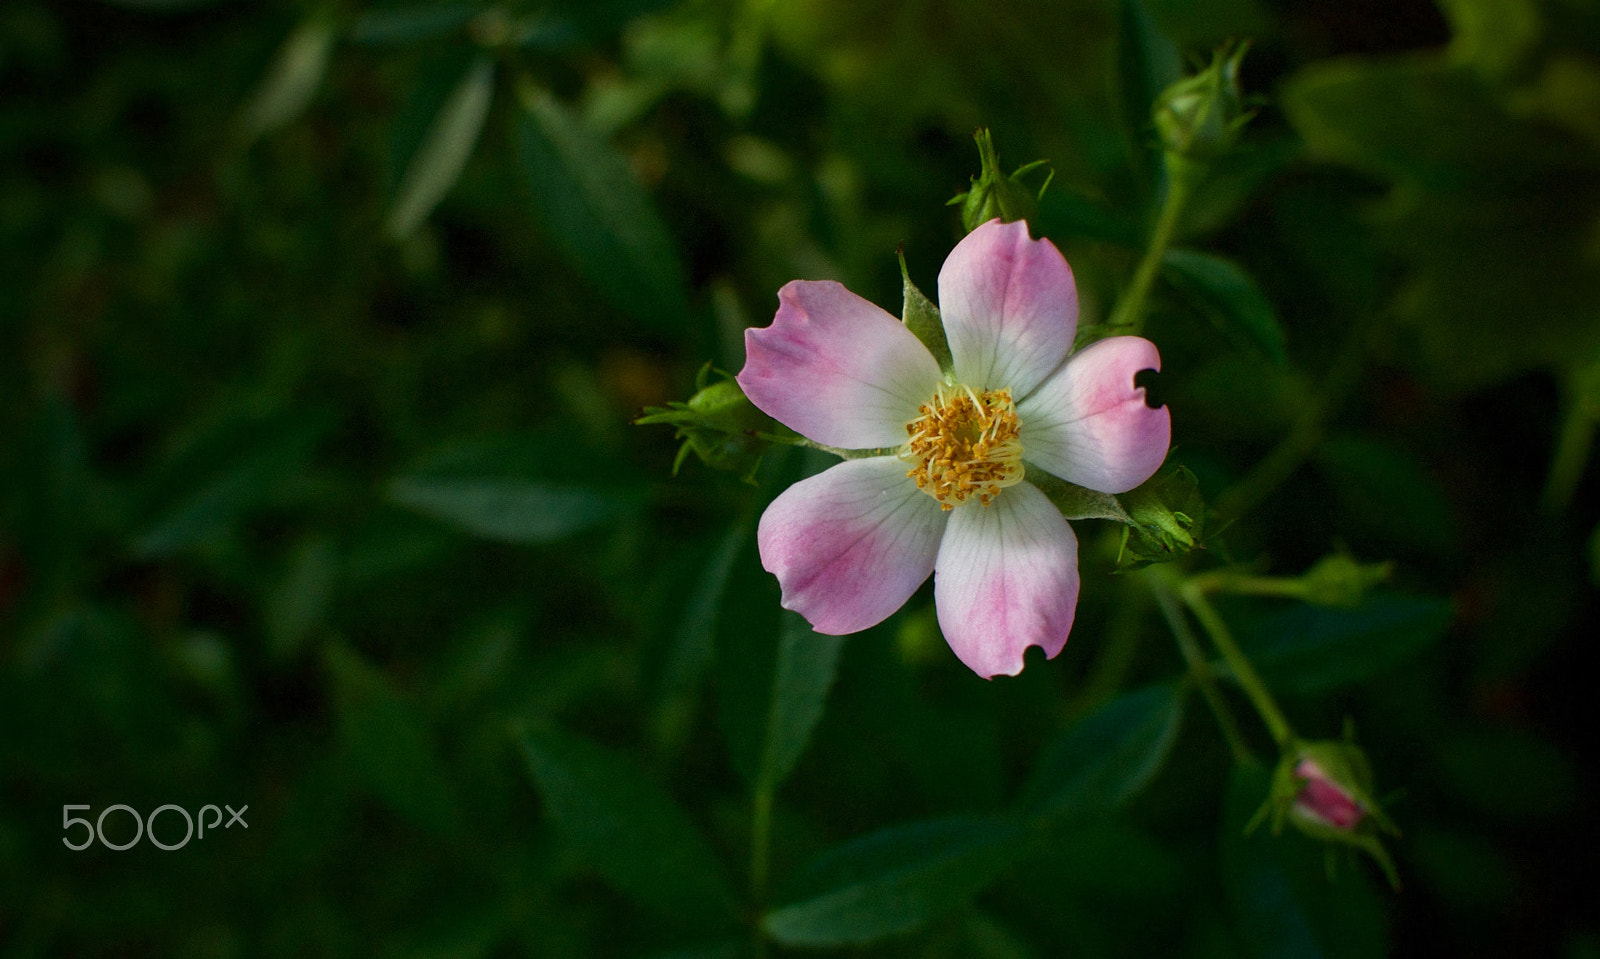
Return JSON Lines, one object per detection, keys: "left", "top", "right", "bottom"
{"left": 762, "top": 817, "right": 1024, "bottom": 948}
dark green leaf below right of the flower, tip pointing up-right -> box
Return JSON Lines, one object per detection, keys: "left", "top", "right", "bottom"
{"left": 1018, "top": 684, "right": 1184, "bottom": 818}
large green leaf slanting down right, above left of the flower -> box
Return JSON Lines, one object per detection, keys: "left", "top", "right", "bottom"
{"left": 517, "top": 90, "right": 688, "bottom": 331}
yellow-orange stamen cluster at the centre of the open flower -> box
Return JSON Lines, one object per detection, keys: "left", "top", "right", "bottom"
{"left": 899, "top": 383, "right": 1022, "bottom": 509}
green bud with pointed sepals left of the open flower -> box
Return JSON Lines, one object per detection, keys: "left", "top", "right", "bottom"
{"left": 634, "top": 363, "right": 782, "bottom": 484}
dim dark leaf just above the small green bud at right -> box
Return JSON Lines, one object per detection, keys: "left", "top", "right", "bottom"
{"left": 1315, "top": 435, "right": 1456, "bottom": 554}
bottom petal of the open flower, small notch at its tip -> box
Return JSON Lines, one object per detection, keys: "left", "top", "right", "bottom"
{"left": 933, "top": 482, "right": 1078, "bottom": 679}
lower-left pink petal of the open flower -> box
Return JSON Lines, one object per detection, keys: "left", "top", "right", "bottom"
{"left": 755, "top": 456, "right": 947, "bottom": 636}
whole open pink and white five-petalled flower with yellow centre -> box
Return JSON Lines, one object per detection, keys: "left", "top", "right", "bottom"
{"left": 738, "top": 221, "right": 1171, "bottom": 679}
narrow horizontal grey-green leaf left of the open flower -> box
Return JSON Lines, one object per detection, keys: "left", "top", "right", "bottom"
{"left": 389, "top": 475, "right": 638, "bottom": 544}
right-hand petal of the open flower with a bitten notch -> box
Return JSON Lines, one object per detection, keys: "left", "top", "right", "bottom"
{"left": 1016, "top": 336, "right": 1173, "bottom": 493}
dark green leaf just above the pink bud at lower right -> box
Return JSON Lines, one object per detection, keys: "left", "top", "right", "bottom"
{"left": 1241, "top": 596, "right": 1454, "bottom": 695}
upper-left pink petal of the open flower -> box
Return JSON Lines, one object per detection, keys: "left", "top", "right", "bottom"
{"left": 738, "top": 280, "right": 941, "bottom": 450}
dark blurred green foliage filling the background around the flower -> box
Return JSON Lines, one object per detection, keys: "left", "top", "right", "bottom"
{"left": 0, "top": 0, "right": 1600, "bottom": 959}
